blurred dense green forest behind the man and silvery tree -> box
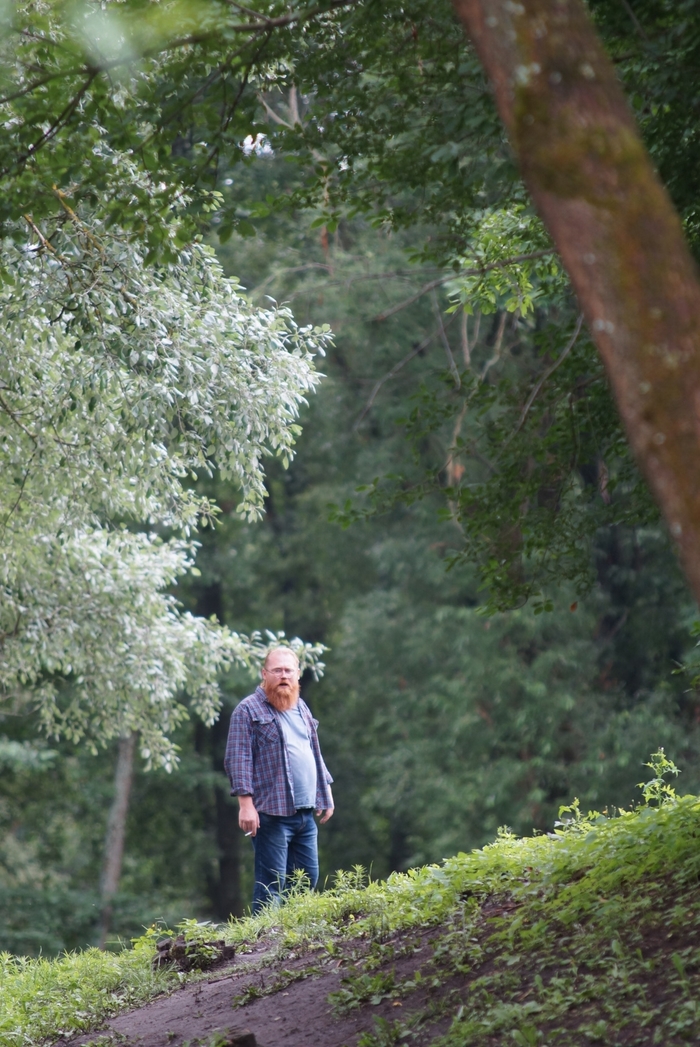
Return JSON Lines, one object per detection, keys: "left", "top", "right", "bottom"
{"left": 0, "top": 175, "right": 700, "bottom": 953}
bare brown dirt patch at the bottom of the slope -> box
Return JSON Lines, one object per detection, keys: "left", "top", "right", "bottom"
{"left": 62, "top": 930, "right": 446, "bottom": 1047}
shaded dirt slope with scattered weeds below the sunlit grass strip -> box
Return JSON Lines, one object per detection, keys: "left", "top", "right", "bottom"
{"left": 62, "top": 883, "right": 700, "bottom": 1047}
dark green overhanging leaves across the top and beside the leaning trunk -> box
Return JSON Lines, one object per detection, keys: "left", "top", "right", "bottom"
{"left": 5, "top": 0, "right": 678, "bottom": 607}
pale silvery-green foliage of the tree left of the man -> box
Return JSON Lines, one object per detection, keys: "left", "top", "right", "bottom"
{"left": 0, "top": 196, "right": 329, "bottom": 766}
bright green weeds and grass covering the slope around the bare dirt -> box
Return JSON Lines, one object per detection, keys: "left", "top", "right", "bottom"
{"left": 0, "top": 752, "right": 700, "bottom": 1047}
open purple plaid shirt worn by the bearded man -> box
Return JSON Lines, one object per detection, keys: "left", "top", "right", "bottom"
{"left": 224, "top": 687, "right": 333, "bottom": 818}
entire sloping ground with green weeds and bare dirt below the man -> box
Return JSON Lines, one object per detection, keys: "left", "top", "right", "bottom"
{"left": 2, "top": 752, "right": 698, "bottom": 1047}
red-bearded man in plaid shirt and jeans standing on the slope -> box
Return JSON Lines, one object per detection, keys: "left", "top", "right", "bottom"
{"left": 224, "top": 647, "right": 333, "bottom": 914}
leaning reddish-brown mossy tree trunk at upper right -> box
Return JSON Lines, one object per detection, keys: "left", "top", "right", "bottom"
{"left": 453, "top": 0, "right": 700, "bottom": 600}
